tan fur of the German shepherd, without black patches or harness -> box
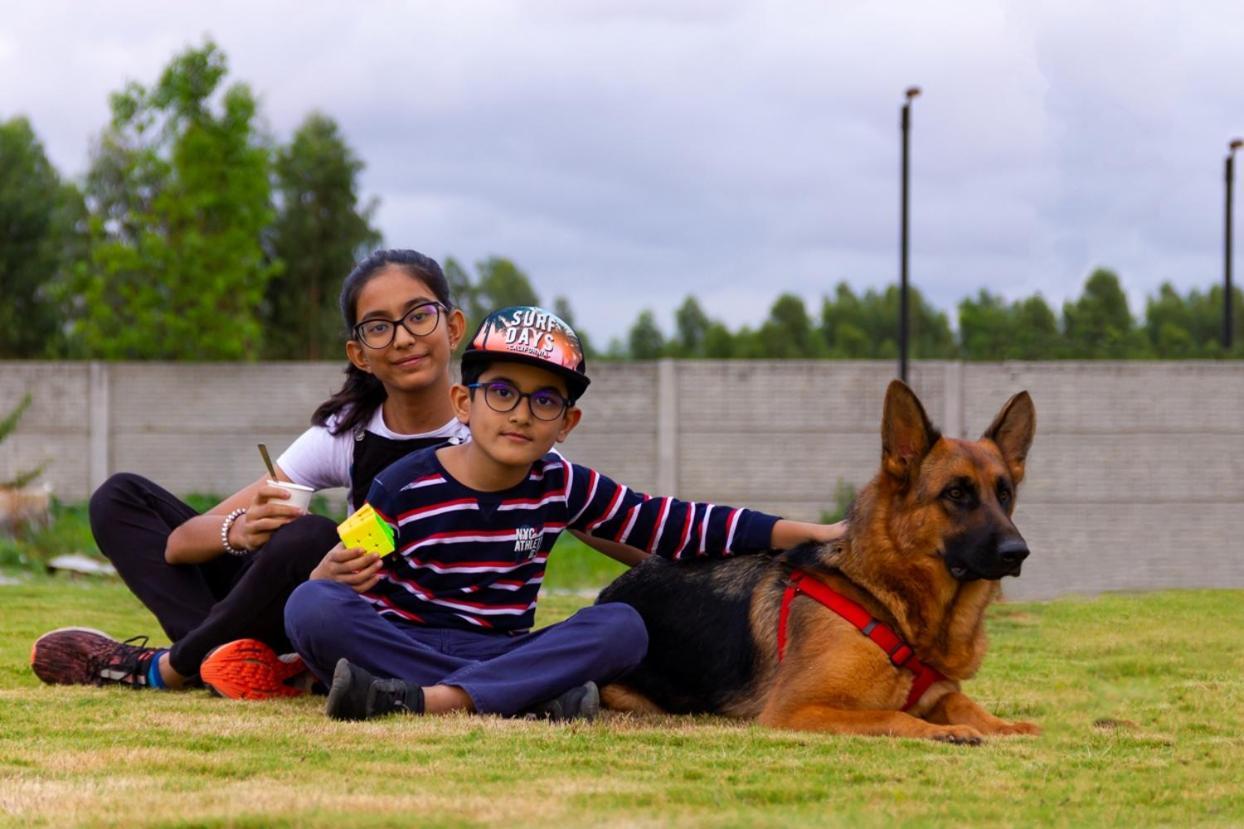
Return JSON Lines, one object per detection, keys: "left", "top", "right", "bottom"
{"left": 605, "top": 381, "right": 1040, "bottom": 743}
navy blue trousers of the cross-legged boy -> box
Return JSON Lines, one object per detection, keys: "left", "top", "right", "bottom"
{"left": 285, "top": 581, "right": 648, "bottom": 714}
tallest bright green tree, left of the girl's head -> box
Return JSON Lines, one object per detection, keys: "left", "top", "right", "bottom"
{"left": 65, "top": 41, "right": 275, "bottom": 360}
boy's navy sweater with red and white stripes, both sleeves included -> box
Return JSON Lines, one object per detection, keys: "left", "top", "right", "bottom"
{"left": 363, "top": 448, "right": 778, "bottom": 634}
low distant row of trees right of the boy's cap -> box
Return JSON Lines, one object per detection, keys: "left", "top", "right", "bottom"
{"left": 617, "top": 268, "right": 1244, "bottom": 360}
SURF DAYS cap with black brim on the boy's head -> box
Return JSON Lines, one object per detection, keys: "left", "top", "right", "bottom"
{"left": 463, "top": 305, "right": 591, "bottom": 400}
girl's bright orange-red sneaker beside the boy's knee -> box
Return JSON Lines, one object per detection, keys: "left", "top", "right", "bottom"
{"left": 199, "top": 639, "right": 315, "bottom": 700}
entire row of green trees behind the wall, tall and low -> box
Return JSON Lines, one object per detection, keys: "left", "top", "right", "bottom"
{"left": 0, "top": 41, "right": 1244, "bottom": 360}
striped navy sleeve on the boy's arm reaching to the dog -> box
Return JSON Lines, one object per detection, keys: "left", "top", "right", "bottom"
{"left": 566, "top": 462, "right": 779, "bottom": 559}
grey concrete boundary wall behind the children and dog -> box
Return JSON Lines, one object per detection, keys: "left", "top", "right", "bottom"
{"left": 0, "top": 360, "right": 1244, "bottom": 597}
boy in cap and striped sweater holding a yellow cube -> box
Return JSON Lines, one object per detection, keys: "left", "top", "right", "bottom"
{"left": 285, "top": 307, "right": 841, "bottom": 719}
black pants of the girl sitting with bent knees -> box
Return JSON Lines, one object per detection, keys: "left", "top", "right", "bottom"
{"left": 91, "top": 472, "right": 337, "bottom": 676}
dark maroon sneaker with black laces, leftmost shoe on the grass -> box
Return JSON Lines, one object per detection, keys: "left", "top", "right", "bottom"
{"left": 30, "top": 627, "right": 165, "bottom": 688}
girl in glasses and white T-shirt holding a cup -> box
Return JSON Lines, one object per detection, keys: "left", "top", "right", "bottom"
{"left": 31, "top": 250, "right": 477, "bottom": 697}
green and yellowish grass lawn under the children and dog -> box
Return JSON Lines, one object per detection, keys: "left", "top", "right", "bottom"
{"left": 0, "top": 540, "right": 1244, "bottom": 827}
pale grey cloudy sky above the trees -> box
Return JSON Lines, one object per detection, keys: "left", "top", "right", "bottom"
{"left": 0, "top": 0, "right": 1244, "bottom": 342}
